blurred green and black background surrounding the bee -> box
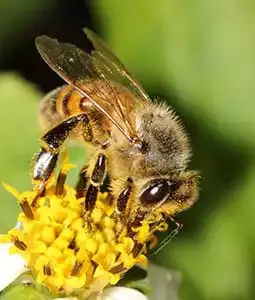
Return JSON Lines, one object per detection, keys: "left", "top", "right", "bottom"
{"left": 0, "top": 0, "right": 255, "bottom": 300}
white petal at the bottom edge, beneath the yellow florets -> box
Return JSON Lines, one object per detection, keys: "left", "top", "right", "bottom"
{"left": 101, "top": 286, "right": 148, "bottom": 300}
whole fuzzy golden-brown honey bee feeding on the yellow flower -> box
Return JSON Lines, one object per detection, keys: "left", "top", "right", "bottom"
{"left": 33, "top": 29, "right": 198, "bottom": 247}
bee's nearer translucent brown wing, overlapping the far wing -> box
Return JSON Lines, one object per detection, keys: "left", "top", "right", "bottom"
{"left": 35, "top": 36, "right": 149, "bottom": 142}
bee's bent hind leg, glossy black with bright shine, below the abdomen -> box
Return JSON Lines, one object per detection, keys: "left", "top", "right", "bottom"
{"left": 32, "top": 114, "right": 93, "bottom": 186}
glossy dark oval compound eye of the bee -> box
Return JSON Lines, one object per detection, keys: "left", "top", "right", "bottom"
{"left": 140, "top": 180, "right": 171, "bottom": 205}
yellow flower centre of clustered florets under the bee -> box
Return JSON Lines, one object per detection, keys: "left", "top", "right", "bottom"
{"left": 0, "top": 155, "right": 167, "bottom": 298}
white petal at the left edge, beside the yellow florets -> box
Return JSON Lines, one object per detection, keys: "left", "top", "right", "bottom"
{"left": 0, "top": 243, "right": 26, "bottom": 291}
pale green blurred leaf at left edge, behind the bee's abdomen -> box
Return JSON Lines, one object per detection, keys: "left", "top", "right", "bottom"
{"left": 0, "top": 74, "right": 41, "bottom": 232}
